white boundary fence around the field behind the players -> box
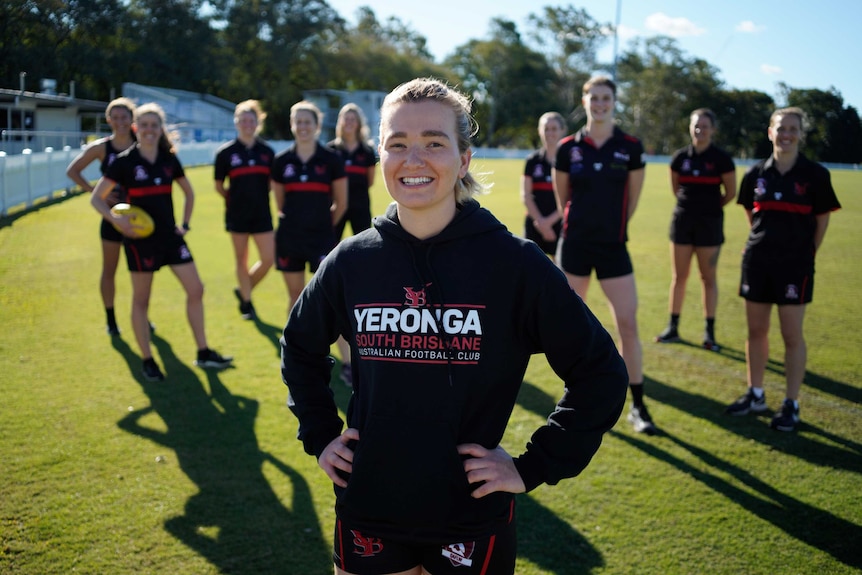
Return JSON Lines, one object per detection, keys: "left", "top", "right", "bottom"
{"left": 0, "top": 141, "right": 860, "bottom": 216}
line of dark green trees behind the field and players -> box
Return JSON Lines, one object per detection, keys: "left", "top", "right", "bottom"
{"left": 6, "top": 0, "right": 862, "bottom": 163}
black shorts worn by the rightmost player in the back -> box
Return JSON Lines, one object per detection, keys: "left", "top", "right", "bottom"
{"left": 739, "top": 253, "right": 814, "bottom": 305}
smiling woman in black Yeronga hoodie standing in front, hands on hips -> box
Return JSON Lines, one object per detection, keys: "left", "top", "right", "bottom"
{"left": 282, "top": 79, "right": 628, "bottom": 575}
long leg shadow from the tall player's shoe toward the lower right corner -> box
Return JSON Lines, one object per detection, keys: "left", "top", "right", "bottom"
{"left": 609, "top": 430, "right": 862, "bottom": 568}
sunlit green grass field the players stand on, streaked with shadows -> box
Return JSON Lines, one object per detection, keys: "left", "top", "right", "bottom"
{"left": 0, "top": 158, "right": 862, "bottom": 575}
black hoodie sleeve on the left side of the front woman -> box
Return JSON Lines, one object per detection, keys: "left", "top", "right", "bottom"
{"left": 281, "top": 264, "right": 344, "bottom": 457}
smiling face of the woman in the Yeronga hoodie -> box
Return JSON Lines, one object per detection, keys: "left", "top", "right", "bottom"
{"left": 378, "top": 100, "right": 471, "bottom": 225}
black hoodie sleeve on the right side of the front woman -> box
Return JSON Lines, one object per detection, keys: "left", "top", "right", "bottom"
{"left": 515, "top": 255, "right": 628, "bottom": 491}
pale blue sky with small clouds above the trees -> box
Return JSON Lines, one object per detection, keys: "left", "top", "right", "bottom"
{"left": 327, "top": 0, "right": 862, "bottom": 114}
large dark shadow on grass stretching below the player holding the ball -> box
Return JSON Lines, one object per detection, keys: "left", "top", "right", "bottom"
{"left": 114, "top": 336, "right": 332, "bottom": 575}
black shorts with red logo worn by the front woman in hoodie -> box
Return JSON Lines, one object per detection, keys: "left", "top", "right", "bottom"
{"left": 332, "top": 510, "right": 517, "bottom": 575}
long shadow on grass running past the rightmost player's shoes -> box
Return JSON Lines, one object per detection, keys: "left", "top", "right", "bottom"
{"left": 644, "top": 377, "right": 862, "bottom": 474}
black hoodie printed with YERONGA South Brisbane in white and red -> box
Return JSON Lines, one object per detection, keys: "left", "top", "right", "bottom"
{"left": 282, "top": 200, "right": 628, "bottom": 542}
